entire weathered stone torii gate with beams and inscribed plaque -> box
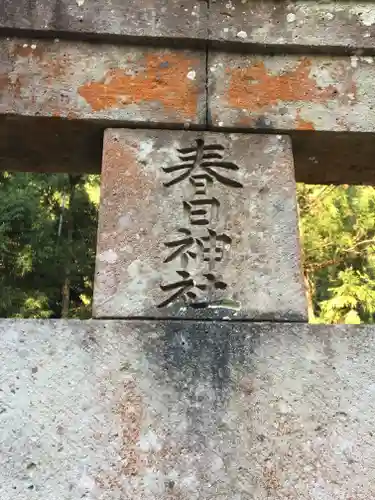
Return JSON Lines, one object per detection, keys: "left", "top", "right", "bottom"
{"left": 0, "top": 0, "right": 375, "bottom": 500}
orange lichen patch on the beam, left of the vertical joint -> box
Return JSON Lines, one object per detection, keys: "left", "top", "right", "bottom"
{"left": 78, "top": 53, "right": 198, "bottom": 119}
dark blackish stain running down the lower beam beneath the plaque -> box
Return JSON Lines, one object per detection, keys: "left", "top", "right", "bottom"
{"left": 140, "top": 321, "right": 259, "bottom": 446}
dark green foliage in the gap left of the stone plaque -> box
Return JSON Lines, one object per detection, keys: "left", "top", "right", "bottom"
{"left": 0, "top": 172, "right": 99, "bottom": 318}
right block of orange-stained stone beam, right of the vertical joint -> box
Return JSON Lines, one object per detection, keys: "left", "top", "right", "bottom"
{"left": 209, "top": 52, "right": 375, "bottom": 132}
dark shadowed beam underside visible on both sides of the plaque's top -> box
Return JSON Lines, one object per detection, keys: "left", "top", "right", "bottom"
{"left": 0, "top": 116, "right": 375, "bottom": 185}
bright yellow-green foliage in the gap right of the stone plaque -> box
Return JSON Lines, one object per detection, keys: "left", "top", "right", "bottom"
{"left": 298, "top": 184, "right": 375, "bottom": 324}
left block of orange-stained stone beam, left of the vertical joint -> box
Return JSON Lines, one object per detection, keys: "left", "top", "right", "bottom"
{"left": 0, "top": 39, "right": 205, "bottom": 124}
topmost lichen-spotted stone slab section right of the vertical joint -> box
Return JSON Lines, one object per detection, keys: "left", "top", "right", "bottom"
{"left": 209, "top": 0, "right": 375, "bottom": 51}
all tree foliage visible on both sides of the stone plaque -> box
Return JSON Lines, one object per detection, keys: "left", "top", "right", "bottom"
{"left": 0, "top": 172, "right": 375, "bottom": 324}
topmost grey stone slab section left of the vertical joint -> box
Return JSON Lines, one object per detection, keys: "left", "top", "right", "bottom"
{"left": 0, "top": 0, "right": 207, "bottom": 39}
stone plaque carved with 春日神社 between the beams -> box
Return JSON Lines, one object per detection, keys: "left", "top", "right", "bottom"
{"left": 94, "top": 129, "right": 306, "bottom": 320}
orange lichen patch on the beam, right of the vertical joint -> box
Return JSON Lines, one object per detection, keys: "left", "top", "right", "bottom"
{"left": 227, "top": 58, "right": 337, "bottom": 110}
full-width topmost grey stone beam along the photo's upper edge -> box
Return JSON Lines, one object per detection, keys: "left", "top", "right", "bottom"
{"left": 0, "top": 0, "right": 375, "bottom": 51}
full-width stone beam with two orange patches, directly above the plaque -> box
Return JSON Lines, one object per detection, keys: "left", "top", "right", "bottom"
{"left": 0, "top": 39, "right": 375, "bottom": 133}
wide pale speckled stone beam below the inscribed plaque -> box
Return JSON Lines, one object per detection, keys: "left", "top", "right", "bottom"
{"left": 0, "top": 320, "right": 375, "bottom": 500}
